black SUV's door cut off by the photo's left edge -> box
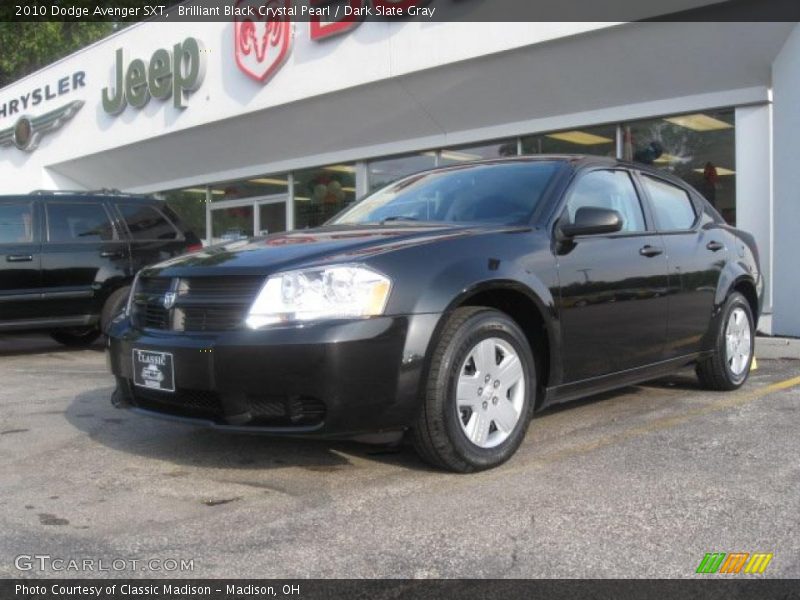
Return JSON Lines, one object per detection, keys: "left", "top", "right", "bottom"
{"left": 0, "top": 197, "right": 42, "bottom": 327}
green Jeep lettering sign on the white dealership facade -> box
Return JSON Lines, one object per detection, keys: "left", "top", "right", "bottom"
{"left": 102, "top": 37, "right": 206, "bottom": 115}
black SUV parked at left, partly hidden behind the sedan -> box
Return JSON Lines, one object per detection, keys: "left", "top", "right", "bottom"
{"left": 0, "top": 191, "right": 202, "bottom": 345}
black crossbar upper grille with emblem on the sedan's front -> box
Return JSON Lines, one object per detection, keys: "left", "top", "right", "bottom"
{"left": 132, "top": 276, "right": 264, "bottom": 332}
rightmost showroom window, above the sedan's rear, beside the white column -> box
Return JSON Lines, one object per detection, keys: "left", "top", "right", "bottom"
{"left": 622, "top": 109, "right": 736, "bottom": 225}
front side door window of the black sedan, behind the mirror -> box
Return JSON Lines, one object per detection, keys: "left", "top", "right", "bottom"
{"left": 566, "top": 171, "right": 647, "bottom": 232}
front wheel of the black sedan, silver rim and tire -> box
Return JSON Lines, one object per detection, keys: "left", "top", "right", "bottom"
{"left": 412, "top": 307, "right": 536, "bottom": 473}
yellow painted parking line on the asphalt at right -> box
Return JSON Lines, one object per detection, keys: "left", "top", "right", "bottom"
{"left": 444, "top": 377, "right": 800, "bottom": 484}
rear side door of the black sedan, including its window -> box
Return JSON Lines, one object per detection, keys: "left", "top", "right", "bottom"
{"left": 639, "top": 173, "right": 728, "bottom": 358}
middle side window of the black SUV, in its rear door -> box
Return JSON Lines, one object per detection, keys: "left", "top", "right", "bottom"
{"left": 47, "top": 202, "right": 114, "bottom": 242}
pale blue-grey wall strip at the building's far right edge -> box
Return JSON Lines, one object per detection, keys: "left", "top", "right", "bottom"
{"left": 772, "top": 25, "right": 800, "bottom": 336}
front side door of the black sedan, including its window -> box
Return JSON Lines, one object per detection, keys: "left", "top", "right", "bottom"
{"left": 556, "top": 169, "right": 668, "bottom": 383}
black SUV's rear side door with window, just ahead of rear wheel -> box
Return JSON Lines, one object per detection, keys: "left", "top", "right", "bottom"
{"left": 42, "top": 199, "right": 129, "bottom": 321}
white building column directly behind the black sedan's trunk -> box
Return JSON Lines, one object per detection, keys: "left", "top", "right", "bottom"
{"left": 736, "top": 104, "right": 773, "bottom": 333}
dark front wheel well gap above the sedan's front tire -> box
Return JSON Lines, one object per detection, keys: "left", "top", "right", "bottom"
{"left": 460, "top": 289, "right": 550, "bottom": 407}
